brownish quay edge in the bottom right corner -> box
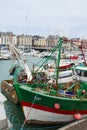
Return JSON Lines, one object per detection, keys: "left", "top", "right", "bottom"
{"left": 57, "top": 118, "right": 87, "bottom": 130}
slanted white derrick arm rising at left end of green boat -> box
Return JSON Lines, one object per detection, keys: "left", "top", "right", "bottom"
{"left": 9, "top": 44, "right": 32, "bottom": 81}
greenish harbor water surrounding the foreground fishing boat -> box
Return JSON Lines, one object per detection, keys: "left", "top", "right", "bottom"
{"left": 0, "top": 56, "right": 67, "bottom": 130}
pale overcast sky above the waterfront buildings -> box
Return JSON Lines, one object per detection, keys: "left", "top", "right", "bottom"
{"left": 0, "top": 0, "right": 87, "bottom": 38}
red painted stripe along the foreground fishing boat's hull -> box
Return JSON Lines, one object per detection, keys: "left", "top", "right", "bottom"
{"left": 21, "top": 101, "right": 87, "bottom": 115}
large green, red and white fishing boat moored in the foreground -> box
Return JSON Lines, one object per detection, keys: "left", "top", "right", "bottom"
{"left": 1, "top": 38, "right": 87, "bottom": 124}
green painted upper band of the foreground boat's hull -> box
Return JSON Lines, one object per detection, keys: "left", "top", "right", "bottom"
{"left": 15, "top": 84, "right": 87, "bottom": 111}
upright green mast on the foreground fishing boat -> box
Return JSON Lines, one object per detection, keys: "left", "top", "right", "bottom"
{"left": 56, "top": 37, "right": 63, "bottom": 85}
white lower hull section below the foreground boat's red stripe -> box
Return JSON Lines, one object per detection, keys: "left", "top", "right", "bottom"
{"left": 22, "top": 106, "right": 74, "bottom": 124}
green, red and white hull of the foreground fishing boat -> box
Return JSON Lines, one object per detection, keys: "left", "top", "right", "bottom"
{"left": 16, "top": 85, "right": 87, "bottom": 124}
